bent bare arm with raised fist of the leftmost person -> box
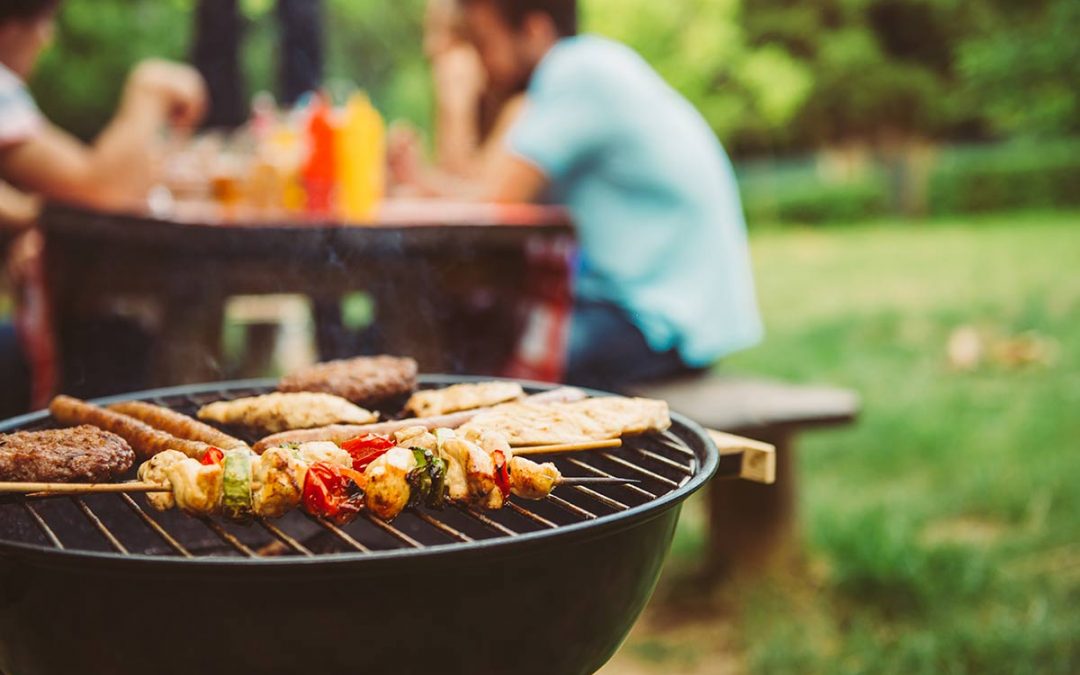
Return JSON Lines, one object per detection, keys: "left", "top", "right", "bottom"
{"left": 0, "top": 60, "right": 205, "bottom": 206}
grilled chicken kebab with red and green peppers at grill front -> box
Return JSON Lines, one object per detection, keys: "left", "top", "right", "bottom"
{"left": 138, "top": 426, "right": 562, "bottom": 522}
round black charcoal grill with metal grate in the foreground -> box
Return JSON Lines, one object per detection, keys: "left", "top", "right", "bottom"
{"left": 0, "top": 376, "right": 738, "bottom": 675}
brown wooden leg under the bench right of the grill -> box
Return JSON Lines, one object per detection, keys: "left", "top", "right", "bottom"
{"left": 706, "top": 429, "right": 796, "bottom": 578}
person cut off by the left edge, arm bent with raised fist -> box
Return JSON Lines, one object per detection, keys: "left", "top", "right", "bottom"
{"left": 0, "top": 0, "right": 205, "bottom": 417}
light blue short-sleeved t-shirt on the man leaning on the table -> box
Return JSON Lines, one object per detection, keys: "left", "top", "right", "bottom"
{"left": 509, "top": 36, "right": 761, "bottom": 366}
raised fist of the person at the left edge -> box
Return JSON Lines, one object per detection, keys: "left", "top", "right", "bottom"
{"left": 125, "top": 59, "right": 207, "bottom": 129}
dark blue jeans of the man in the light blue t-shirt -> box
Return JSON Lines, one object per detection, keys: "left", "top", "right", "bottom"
{"left": 564, "top": 300, "right": 694, "bottom": 392}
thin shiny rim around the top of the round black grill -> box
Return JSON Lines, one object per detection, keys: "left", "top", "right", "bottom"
{"left": 0, "top": 375, "right": 719, "bottom": 573}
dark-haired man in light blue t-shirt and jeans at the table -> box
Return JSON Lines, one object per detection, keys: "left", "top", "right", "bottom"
{"left": 393, "top": 0, "right": 761, "bottom": 389}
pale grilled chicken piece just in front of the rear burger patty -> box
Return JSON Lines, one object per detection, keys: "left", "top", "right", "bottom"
{"left": 199, "top": 392, "right": 378, "bottom": 433}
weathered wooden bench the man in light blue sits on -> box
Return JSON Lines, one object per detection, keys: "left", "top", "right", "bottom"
{"left": 632, "top": 374, "right": 860, "bottom": 576}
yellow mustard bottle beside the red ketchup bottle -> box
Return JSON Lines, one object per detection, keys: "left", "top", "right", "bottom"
{"left": 337, "top": 92, "right": 386, "bottom": 224}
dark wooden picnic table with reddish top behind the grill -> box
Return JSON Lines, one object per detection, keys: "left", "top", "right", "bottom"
{"left": 41, "top": 201, "right": 571, "bottom": 395}
